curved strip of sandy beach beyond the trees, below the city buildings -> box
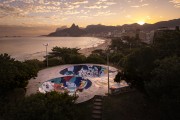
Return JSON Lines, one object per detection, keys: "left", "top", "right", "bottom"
{"left": 79, "top": 38, "right": 111, "bottom": 57}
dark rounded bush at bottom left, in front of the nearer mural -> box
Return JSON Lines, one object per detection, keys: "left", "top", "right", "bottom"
{"left": 4, "top": 92, "right": 76, "bottom": 120}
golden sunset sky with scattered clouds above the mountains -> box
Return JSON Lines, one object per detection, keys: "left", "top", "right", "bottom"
{"left": 0, "top": 0, "right": 180, "bottom": 35}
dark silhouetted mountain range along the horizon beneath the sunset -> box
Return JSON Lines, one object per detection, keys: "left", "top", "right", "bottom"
{"left": 48, "top": 18, "right": 180, "bottom": 37}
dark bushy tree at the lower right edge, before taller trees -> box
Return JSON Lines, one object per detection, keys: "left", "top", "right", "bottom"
{"left": 145, "top": 56, "right": 180, "bottom": 120}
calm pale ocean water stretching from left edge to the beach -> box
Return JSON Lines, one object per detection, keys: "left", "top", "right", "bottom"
{"left": 0, "top": 37, "right": 104, "bottom": 61}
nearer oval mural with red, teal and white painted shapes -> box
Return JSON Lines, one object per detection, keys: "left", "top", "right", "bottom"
{"left": 39, "top": 76, "right": 92, "bottom": 94}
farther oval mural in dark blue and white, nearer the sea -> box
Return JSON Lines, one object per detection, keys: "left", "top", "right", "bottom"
{"left": 60, "top": 65, "right": 108, "bottom": 77}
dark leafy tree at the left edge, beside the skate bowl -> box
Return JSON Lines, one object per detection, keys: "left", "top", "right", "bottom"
{"left": 0, "top": 54, "right": 39, "bottom": 95}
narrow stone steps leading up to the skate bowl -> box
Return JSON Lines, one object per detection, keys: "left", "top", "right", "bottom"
{"left": 92, "top": 95, "right": 103, "bottom": 120}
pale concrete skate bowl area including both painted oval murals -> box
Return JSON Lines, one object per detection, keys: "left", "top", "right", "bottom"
{"left": 26, "top": 64, "right": 118, "bottom": 103}
